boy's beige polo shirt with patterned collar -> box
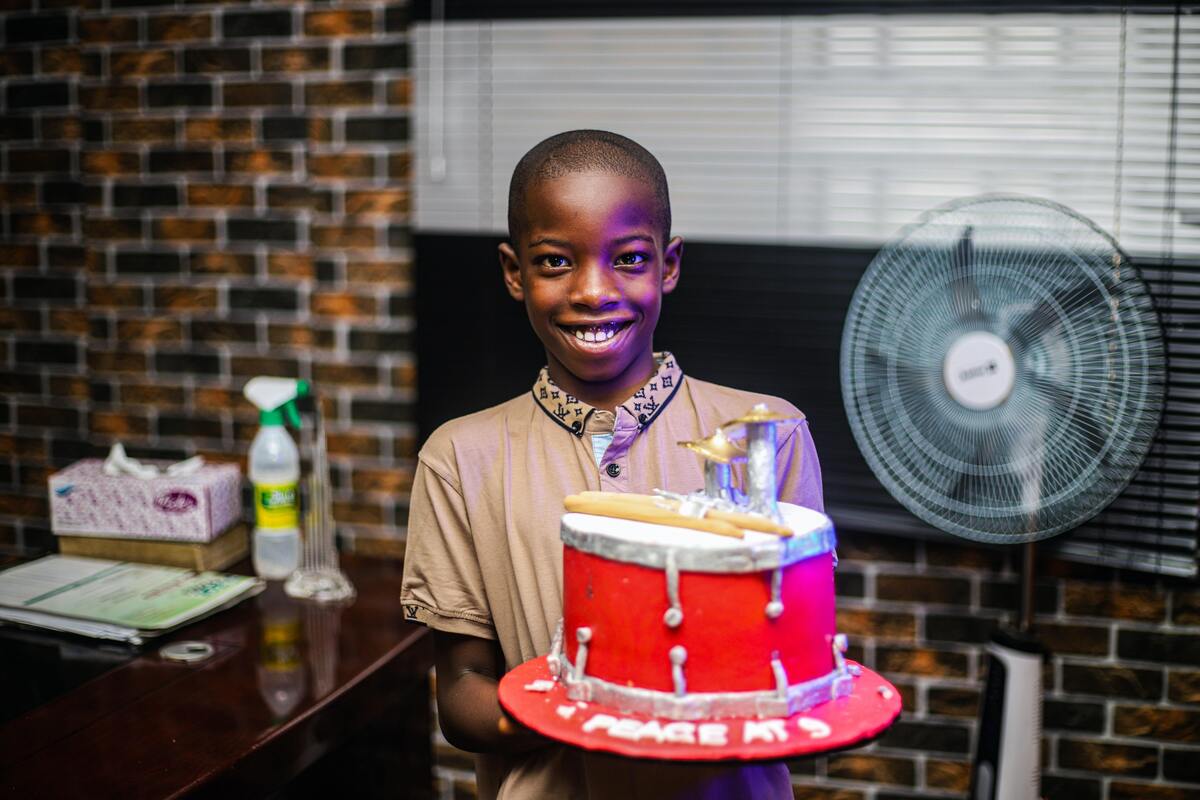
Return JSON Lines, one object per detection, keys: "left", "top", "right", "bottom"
{"left": 401, "top": 353, "right": 824, "bottom": 800}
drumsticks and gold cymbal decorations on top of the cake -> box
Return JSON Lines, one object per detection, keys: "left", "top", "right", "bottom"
{"left": 564, "top": 403, "right": 804, "bottom": 539}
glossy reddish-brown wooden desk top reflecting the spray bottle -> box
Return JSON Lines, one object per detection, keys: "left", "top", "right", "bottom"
{"left": 0, "top": 557, "right": 433, "bottom": 799}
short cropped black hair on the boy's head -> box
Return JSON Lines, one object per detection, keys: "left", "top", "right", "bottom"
{"left": 509, "top": 130, "right": 671, "bottom": 245}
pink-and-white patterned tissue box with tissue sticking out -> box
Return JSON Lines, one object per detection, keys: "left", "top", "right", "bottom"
{"left": 49, "top": 458, "right": 241, "bottom": 542}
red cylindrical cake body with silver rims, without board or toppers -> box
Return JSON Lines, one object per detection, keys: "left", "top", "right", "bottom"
{"left": 550, "top": 504, "right": 851, "bottom": 720}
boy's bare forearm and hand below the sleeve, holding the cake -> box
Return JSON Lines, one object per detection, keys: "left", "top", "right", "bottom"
{"left": 433, "top": 631, "right": 552, "bottom": 753}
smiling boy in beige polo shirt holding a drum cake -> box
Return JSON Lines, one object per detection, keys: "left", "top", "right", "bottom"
{"left": 401, "top": 131, "right": 823, "bottom": 800}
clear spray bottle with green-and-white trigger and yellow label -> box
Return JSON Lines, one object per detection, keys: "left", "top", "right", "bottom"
{"left": 244, "top": 378, "right": 308, "bottom": 581}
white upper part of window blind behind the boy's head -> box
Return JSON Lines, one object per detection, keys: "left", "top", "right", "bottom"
{"left": 414, "top": 13, "right": 1200, "bottom": 262}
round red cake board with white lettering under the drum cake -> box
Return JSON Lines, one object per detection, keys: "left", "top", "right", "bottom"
{"left": 500, "top": 656, "right": 900, "bottom": 762}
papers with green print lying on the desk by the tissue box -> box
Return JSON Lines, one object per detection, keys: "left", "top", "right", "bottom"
{"left": 0, "top": 555, "right": 263, "bottom": 642}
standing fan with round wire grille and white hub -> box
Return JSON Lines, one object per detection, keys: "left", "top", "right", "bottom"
{"left": 841, "top": 196, "right": 1165, "bottom": 800}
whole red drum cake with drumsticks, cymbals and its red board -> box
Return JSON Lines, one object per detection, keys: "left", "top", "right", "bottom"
{"left": 499, "top": 405, "right": 900, "bottom": 760}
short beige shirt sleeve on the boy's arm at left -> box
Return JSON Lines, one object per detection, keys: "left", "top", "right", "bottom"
{"left": 400, "top": 461, "right": 496, "bottom": 639}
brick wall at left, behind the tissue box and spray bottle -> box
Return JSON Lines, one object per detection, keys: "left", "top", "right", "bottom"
{"left": 0, "top": 0, "right": 415, "bottom": 552}
